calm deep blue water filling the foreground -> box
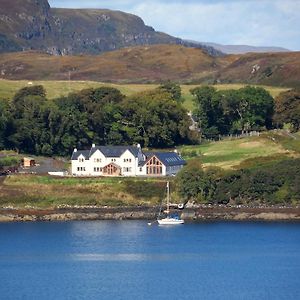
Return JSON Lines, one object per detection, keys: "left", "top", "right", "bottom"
{"left": 0, "top": 221, "right": 300, "bottom": 300}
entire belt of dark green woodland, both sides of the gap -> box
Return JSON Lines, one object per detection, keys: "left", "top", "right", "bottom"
{"left": 0, "top": 82, "right": 300, "bottom": 156}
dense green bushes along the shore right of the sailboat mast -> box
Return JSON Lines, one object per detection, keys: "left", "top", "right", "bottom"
{"left": 176, "top": 158, "right": 300, "bottom": 205}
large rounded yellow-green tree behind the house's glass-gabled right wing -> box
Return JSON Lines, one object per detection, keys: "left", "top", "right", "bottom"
{"left": 120, "top": 90, "right": 190, "bottom": 148}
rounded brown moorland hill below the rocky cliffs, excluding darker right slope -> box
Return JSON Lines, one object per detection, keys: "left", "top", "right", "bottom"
{"left": 0, "top": 45, "right": 228, "bottom": 82}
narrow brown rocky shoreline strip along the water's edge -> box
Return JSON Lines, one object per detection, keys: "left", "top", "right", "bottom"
{"left": 0, "top": 205, "right": 300, "bottom": 223}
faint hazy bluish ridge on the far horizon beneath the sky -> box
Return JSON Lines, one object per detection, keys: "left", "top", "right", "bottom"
{"left": 187, "top": 41, "right": 290, "bottom": 54}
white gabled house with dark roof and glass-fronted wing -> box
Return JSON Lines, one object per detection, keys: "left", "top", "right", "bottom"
{"left": 71, "top": 144, "right": 186, "bottom": 176}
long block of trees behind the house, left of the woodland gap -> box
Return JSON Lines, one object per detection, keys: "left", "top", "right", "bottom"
{"left": 0, "top": 84, "right": 193, "bottom": 156}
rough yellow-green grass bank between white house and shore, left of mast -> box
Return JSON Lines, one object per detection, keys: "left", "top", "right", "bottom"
{"left": 0, "top": 175, "right": 171, "bottom": 208}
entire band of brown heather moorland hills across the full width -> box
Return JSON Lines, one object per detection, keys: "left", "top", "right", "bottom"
{"left": 0, "top": 45, "right": 300, "bottom": 87}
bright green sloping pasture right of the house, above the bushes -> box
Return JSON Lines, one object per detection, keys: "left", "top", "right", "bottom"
{"left": 180, "top": 132, "right": 300, "bottom": 169}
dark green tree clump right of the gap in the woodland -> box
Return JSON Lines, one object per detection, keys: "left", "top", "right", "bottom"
{"left": 191, "top": 86, "right": 300, "bottom": 139}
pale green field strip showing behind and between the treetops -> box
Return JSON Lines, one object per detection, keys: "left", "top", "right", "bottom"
{"left": 0, "top": 80, "right": 287, "bottom": 110}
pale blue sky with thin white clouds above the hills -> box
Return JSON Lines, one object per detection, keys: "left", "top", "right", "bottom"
{"left": 49, "top": 0, "right": 300, "bottom": 50}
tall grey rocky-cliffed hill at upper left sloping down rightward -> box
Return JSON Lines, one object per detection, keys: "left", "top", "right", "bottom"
{"left": 0, "top": 0, "right": 222, "bottom": 56}
